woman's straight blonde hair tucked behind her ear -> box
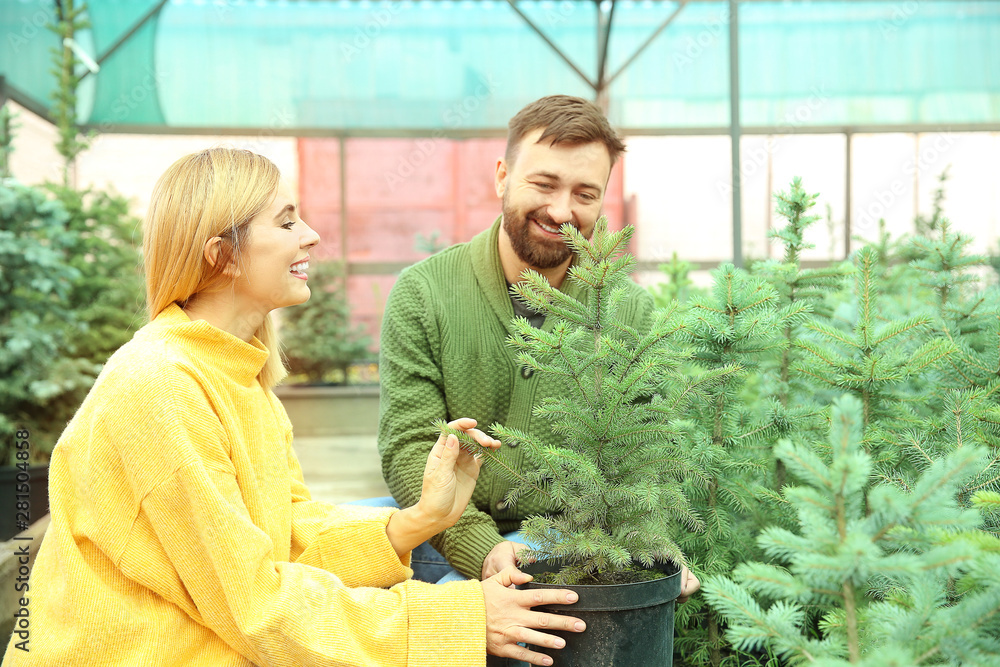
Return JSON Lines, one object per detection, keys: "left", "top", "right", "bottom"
{"left": 142, "top": 148, "right": 287, "bottom": 387}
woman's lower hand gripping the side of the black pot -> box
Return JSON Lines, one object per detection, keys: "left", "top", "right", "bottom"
{"left": 481, "top": 567, "right": 587, "bottom": 665}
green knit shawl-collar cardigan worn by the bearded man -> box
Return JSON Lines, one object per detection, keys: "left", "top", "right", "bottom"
{"left": 378, "top": 218, "right": 653, "bottom": 579}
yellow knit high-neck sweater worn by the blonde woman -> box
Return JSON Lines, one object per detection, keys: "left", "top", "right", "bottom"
{"left": 3, "top": 306, "right": 486, "bottom": 667}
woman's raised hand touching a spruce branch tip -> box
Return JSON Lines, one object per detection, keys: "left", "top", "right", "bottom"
{"left": 385, "top": 419, "right": 500, "bottom": 557}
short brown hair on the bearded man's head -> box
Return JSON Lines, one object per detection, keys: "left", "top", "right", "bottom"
{"left": 504, "top": 95, "right": 625, "bottom": 168}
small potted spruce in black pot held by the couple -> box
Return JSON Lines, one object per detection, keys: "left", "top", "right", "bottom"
{"left": 436, "top": 217, "right": 712, "bottom": 666}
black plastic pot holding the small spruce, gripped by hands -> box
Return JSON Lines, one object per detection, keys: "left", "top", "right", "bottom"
{"left": 510, "top": 563, "right": 681, "bottom": 667}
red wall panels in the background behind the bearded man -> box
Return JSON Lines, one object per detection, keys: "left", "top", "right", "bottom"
{"left": 298, "top": 138, "right": 625, "bottom": 349}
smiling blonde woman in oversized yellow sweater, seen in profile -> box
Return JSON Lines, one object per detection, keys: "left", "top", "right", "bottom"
{"left": 4, "top": 148, "right": 582, "bottom": 667}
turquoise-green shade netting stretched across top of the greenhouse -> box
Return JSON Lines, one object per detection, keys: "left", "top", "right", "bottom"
{"left": 0, "top": 0, "right": 1000, "bottom": 134}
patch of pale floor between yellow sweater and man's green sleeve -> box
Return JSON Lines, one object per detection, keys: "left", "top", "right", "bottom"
{"left": 292, "top": 434, "right": 390, "bottom": 503}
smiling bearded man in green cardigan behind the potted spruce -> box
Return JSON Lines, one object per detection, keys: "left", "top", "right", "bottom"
{"left": 378, "top": 95, "right": 698, "bottom": 597}
